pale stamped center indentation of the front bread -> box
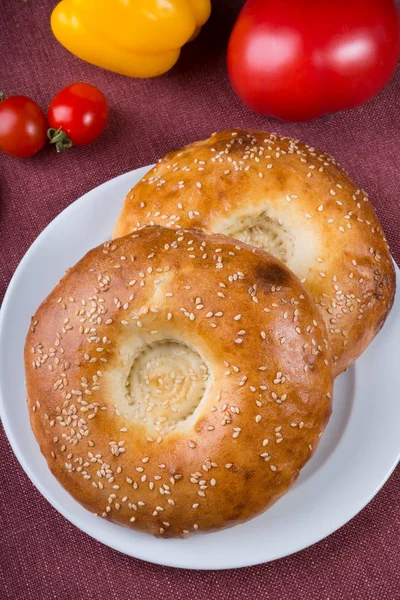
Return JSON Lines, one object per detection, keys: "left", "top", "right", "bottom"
{"left": 126, "top": 340, "right": 210, "bottom": 433}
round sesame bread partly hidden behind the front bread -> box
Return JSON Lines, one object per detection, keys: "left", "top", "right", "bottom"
{"left": 114, "top": 130, "right": 395, "bottom": 375}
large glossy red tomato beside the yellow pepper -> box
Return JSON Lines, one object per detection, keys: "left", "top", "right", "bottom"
{"left": 228, "top": 0, "right": 400, "bottom": 121}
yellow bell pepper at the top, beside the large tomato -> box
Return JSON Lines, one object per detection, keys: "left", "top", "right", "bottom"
{"left": 51, "top": 0, "right": 211, "bottom": 77}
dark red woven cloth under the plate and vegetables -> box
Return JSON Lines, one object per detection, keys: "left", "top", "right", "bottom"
{"left": 0, "top": 0, "right": 400, "bottom": 600}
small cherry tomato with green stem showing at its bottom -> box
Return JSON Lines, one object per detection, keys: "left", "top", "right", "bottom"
{"left": 48, "top": 83, "right": 108, "bottom": 150}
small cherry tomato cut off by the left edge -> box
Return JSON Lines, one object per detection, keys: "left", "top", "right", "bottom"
{"left": 0, "top": 96, "right": 47, "bottom": 158}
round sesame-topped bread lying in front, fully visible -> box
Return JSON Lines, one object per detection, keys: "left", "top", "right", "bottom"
{"left": 25, "top": 227, "right": 333, "bottom": 537}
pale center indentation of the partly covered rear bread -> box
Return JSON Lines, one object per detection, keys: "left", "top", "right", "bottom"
{"left": 223, "top": 212, "right": 294, "bottom": 263}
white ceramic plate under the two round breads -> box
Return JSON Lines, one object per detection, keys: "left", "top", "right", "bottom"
{"left": 0, "top": 167, "right": 400, "bottom": 569}
